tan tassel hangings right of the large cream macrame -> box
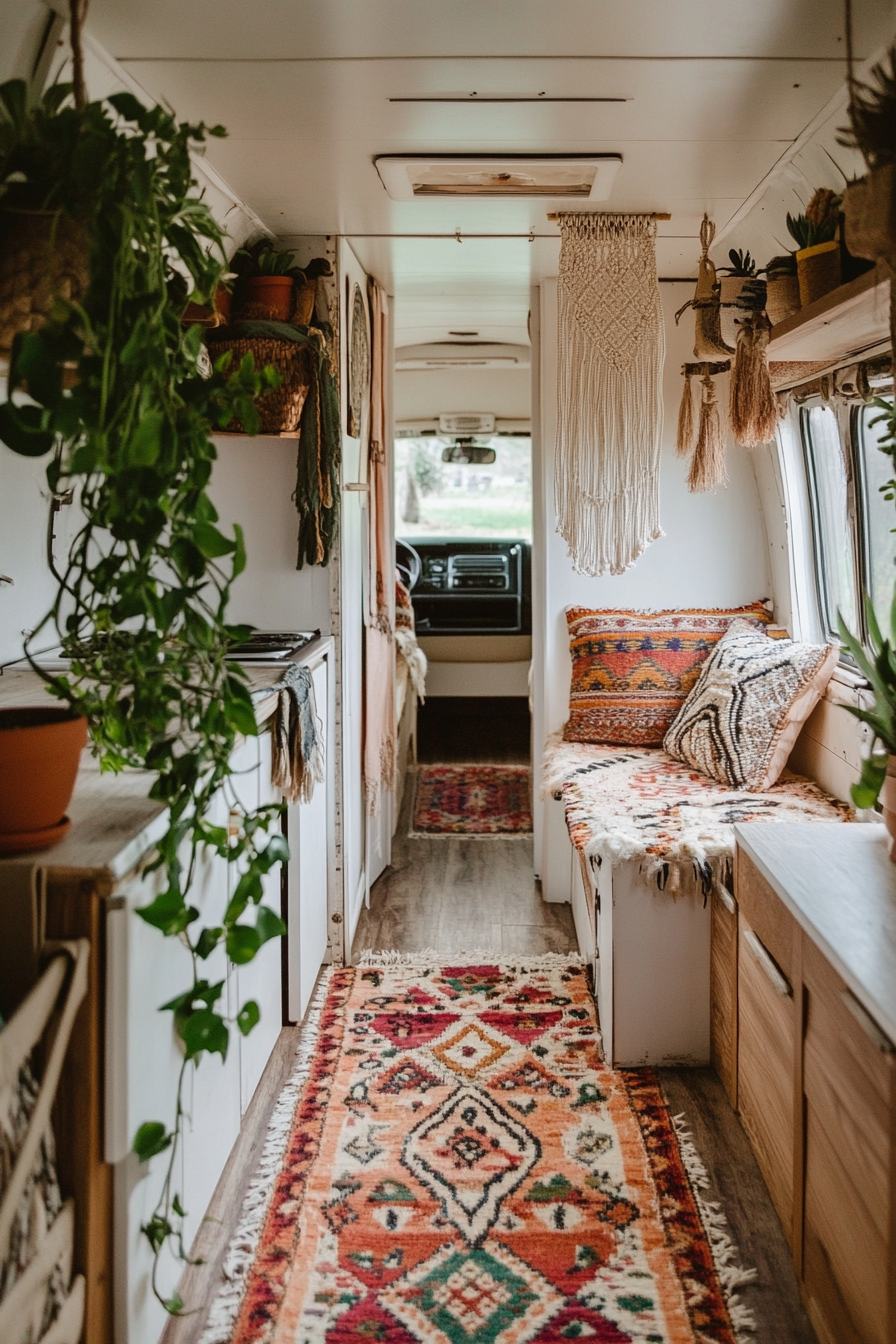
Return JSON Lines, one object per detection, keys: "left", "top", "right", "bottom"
{"left": 676, "top": 215, "right": 778, "bottom": 493}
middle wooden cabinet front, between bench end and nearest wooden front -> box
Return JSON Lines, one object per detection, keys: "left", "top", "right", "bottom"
{"left": 737, "top": 906, "right": 795, "bottom": 1245}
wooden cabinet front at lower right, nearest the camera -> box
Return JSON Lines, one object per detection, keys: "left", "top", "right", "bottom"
{"left": 803, "top": 939, "right": 895, "bottom": 1344}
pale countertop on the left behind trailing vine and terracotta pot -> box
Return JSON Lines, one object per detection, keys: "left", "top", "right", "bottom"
{"left": 0, "top": 636, "right": 333, "bottom": 886}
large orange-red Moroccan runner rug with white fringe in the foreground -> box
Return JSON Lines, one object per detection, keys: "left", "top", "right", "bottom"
{"left": 203, "top": 953, "right": 751, "bottom": 1344}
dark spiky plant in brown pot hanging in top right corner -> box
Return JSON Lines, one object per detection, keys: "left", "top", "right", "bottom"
{"left": 838, "top": 47, "right": 896, "bottom": 270}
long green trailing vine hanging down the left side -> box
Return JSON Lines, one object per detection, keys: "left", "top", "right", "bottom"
{"left": 0, "top": 82, "right": 287, "bottom": 1313}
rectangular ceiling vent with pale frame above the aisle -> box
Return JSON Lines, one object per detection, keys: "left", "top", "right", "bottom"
{"left": 373, "top": 155, "right": 622, "bottom": 200}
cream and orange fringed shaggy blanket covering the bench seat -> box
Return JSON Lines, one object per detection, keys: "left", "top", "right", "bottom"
{"left": 541, "top": 735, "right": 852, "bottom": 888}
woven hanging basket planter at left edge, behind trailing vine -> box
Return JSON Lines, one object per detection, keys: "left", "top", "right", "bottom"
{"left": 0, "top": 210, "right": 90, "bottom": 355}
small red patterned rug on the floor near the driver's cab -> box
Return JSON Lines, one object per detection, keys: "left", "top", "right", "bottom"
{"left": 411, "top": 765, "right": 532, "bottom": 839}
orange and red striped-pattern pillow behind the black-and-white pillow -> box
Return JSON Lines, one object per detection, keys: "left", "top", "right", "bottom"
{"left": 563, "top": 602, "right": 771, "bottom": 747}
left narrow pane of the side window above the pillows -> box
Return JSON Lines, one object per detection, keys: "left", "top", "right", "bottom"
{"left": 801, "top": 405, "right": 858, "bottom": 638}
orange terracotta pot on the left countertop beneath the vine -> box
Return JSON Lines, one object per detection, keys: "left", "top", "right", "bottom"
{"left": 0, "top": 706, "right": 87, "bottom": 852}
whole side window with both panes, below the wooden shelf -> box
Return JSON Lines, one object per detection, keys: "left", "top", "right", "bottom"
{"left": 799, "top": 402, "right": 896, "bottom": 642}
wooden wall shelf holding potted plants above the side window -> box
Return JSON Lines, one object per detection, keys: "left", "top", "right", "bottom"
{"left": 768, "top": 266, "right": 889, "bottom": 363}
